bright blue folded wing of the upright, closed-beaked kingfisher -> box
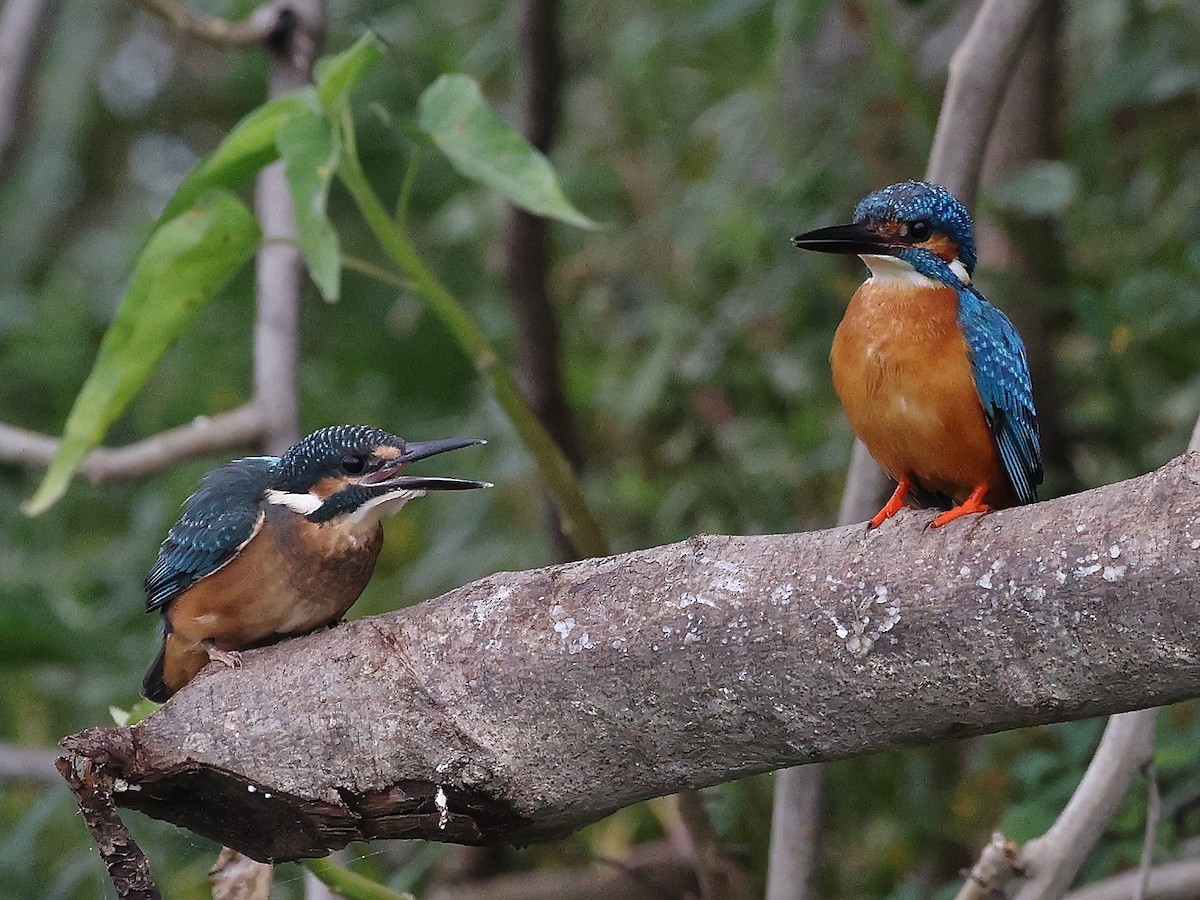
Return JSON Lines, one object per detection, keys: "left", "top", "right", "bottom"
{"left": 959, "top": 287, "right": 1043, "bottom": 503}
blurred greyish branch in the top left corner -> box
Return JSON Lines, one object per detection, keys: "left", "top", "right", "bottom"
{"left": 0, "top": 0, "right": 59, "bottom": 182}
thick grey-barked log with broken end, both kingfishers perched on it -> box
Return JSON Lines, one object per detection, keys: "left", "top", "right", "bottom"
{"left": 58, "top": 454, "right": 1200, "bottom": 860}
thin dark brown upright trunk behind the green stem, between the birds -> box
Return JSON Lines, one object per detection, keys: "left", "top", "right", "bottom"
{"left": 504, "top": 0, "right": 580, "bottom": 562}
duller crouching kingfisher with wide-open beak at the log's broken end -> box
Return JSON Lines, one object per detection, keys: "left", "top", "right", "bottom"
{"left": 142, "top": 425, "right": 492, "bottom": 703}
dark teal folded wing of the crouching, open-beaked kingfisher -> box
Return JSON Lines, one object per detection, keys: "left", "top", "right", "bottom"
{"left": 145, "top": 457, "right": 276, "bottom": 612}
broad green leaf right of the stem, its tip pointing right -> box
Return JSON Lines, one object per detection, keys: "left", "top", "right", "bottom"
{"left": 418, "top": 74, "right": 596, "bottom": 228}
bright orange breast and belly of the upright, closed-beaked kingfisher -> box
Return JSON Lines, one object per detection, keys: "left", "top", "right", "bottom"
{"left": 829, "top": 281, "right": 1015, "bottom": 506}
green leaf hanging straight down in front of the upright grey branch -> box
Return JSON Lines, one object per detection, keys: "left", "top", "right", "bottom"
{"left": 275, "top": 110, "right": 342, "bottom": 301}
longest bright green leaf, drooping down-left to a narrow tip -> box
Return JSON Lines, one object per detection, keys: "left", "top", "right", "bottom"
{"left": 24, "top": 190, "right": 259, "bottom": 516}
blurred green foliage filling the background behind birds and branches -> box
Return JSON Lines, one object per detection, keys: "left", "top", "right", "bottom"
{"left": 0, "top": 0, "right": 1200, "bottom": 899}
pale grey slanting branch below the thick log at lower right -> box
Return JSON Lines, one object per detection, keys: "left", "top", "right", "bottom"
{"left": 1016, "top": 709, "right": 1158, "bottom": 900}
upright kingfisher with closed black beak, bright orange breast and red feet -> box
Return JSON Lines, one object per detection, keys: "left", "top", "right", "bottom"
{"left": 792, "top": 181, "right": 1043, "bottom": 528}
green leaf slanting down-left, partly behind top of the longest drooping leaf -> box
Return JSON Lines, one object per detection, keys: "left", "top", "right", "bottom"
{"left": 158, "top": 88, "right": 316, "bottom": 224}
